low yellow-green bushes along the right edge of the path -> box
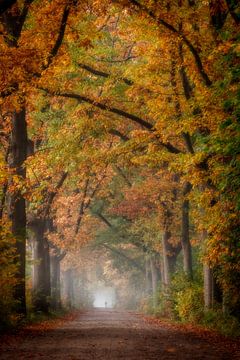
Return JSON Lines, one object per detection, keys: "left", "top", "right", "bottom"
{"left": 144, "top": 272, "right": 240, "bottom": 336}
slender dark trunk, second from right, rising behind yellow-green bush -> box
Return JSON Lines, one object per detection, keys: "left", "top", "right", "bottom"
{"left": 181, "top": 199, "right": 193, "bottom": 279}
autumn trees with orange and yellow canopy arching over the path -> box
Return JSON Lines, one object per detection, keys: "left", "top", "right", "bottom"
{"left": 0, "top": 0, "right": 240, "bottom": 326}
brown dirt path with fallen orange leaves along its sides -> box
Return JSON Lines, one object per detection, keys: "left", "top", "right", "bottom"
{"left": 0, "top": 309, "right": 240, "bottom": 360}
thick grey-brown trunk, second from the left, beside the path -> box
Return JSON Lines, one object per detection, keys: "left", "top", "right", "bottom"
{"left": 31, "top": 218, "right": 51, "bottom": 313}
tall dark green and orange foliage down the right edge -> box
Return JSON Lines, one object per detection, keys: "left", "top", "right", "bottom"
{"left": 203, "top": 37, "right": 240, "bottom": 319}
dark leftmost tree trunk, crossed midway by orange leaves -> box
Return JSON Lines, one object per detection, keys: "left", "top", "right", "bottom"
{"left": 8, "top": 108, "right": 28, "bottom": 314}
